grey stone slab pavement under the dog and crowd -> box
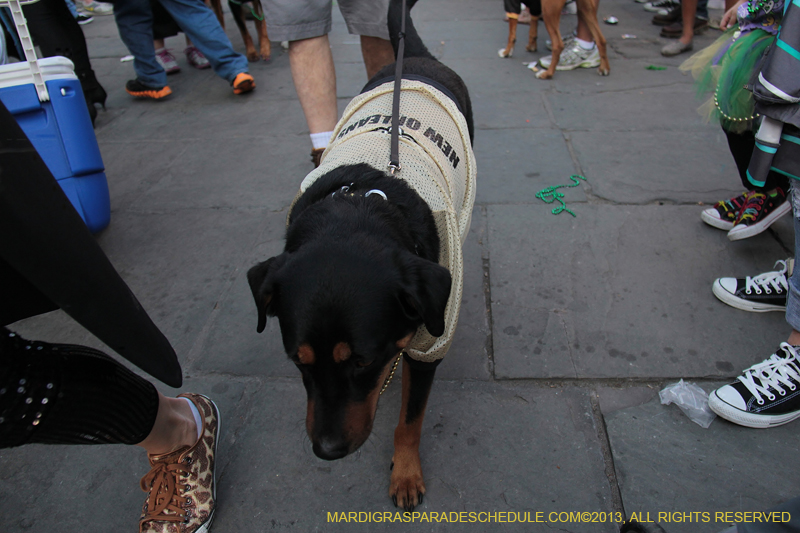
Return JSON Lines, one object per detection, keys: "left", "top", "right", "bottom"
{"left": 0, "top": 0, "right": 800, "bottom": 533}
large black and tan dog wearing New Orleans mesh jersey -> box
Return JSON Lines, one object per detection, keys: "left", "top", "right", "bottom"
{"left": 247, "top": 0, "right": 476, "bottom": 510}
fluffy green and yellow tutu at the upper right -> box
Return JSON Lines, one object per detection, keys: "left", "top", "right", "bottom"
{"left": 679, "top": 28, "right": 775, "bottom": 133}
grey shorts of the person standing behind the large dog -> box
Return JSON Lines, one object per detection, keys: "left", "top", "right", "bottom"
{"left": 261, "top": 0, "right": 389, "bottom": 41}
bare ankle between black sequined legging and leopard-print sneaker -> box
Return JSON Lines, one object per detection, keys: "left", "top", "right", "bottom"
{"left": 137, "top": 392, "right": 197, "bottom": 455}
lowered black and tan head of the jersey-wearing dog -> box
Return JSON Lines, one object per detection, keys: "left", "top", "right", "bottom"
{"left": 247, "top": 243, "right": 451, "bottom": 460}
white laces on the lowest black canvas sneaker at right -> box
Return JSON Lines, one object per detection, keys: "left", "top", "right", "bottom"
{"left": 737, "top": 342, "right": 800, "bottom": 405}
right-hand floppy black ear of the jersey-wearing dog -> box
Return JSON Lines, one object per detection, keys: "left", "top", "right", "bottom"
{"left": 399, "top": 254, "right": 452, "bottom": 337}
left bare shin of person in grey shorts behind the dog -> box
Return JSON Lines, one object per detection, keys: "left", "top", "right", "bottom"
{"left": 289, "top": 35, "right": 339, "bottom": 133}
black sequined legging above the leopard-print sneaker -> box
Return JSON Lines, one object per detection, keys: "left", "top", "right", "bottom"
{"left": 0, "top": 328, "right": 158, "bottom": 448}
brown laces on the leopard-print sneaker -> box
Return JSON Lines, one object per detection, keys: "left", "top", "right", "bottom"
{"left": 139, "top": 456, "right": 192, "bottom": 524}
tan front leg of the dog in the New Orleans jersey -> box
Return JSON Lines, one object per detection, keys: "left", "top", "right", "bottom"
{"left": 389, "top": 356, "right": 436, "bottom": 511}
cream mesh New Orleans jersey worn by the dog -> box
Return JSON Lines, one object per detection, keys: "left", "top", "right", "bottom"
{"left": 300, "top": 79, "right": 477, "bottom": 362}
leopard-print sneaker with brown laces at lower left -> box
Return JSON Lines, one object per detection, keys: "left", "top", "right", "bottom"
{"left": 139, "top": 393, "right": 219, "bottom": 533}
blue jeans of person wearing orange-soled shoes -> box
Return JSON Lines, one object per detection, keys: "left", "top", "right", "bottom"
{"left": 113, "top": 0, "right": 248, "bottom": 87}
